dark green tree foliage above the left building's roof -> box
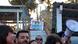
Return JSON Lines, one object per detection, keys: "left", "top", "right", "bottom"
{"left": 8, "top": 0, "right": 37, "bottom": 10}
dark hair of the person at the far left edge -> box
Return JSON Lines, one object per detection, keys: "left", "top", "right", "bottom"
{"left": 0, "top": 25, "right": 13, "bottom": 44}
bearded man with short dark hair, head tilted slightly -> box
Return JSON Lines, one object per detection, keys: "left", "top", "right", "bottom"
{"left": 16, "top": 30, "right": 30, "bottom": 44}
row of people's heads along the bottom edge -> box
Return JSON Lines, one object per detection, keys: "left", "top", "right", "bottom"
{"left": 0, "top": 25, "right": 71, "bottom": 44}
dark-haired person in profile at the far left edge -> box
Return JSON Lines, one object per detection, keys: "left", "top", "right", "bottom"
{"left": 0, "top": 25, "right": 14, "bottom": 44}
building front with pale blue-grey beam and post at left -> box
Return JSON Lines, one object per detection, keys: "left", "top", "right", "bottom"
{"left": 0, "top": 5, "right": 26, "bottom": 31}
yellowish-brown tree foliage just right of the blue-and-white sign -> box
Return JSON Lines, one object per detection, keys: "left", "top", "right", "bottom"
{"left": 40, "top": 10, "right": 52, "bottom": 34}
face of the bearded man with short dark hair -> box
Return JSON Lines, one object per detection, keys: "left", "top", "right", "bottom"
{"left": 17, "top": 33, "right": 29, "bottom": 44}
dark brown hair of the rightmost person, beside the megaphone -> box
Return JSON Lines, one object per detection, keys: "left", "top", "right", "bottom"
{"left": 45, "top": 34, "right": 62, "bottom": 44}
